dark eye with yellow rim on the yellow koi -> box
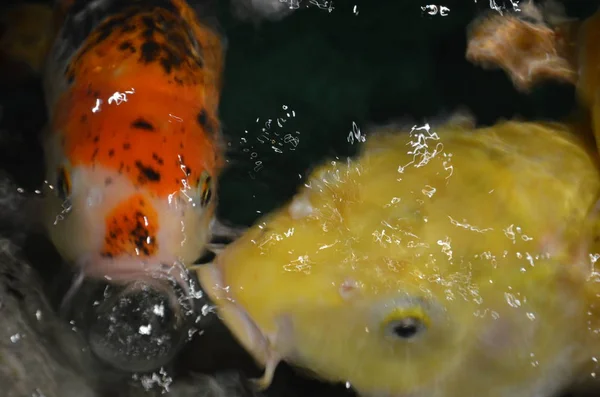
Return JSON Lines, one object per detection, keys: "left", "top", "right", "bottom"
{"left": 383, "top": 307, "right": 429, "bottom": 340}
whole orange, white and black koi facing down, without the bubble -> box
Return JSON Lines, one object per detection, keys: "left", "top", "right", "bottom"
{"left": 43, "top": 0, "right": 232, "bottom": 302}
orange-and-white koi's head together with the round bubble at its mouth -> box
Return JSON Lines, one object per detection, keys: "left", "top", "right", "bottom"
{"left": 44, "top": 96, "right": 223, "bottom": 371}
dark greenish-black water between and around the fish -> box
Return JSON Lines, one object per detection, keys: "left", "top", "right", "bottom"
{"left": 0, "top": 0, "right": 600, "bottom": 396}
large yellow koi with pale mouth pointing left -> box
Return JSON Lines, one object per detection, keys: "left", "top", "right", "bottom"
{"left": 198, "top": 121, "right": 600, "bottom": 397}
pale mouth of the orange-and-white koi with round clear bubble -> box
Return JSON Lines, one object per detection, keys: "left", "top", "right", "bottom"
{"left": 63, "top": 257, "right": 196, "bottom": 372}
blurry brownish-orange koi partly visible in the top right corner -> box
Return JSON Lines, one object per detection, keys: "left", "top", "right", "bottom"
{"left": 466, "top": 0, "right": 600, "bottom": 148}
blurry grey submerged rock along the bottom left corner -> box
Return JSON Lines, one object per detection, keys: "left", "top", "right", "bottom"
{"left": 0, "top": 175, "right": 255, "bottom": 397}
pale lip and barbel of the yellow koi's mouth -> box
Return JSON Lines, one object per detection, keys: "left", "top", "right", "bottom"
{"left": 196, "top": 262, "right": 279, "bottom": 389}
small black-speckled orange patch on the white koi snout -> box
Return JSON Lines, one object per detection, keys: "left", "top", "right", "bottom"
{"left": 101, "top": 194, "right": 159, "bottom": 258}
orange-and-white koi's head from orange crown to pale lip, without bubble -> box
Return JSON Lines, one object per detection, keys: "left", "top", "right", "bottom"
{"left": 46, "top": 100, "right": 215, "bottom": 292}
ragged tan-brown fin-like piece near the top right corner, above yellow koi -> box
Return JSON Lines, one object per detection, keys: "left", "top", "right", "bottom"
{"left": 466, "top": 2, "right": 578, "bottom": 92}
